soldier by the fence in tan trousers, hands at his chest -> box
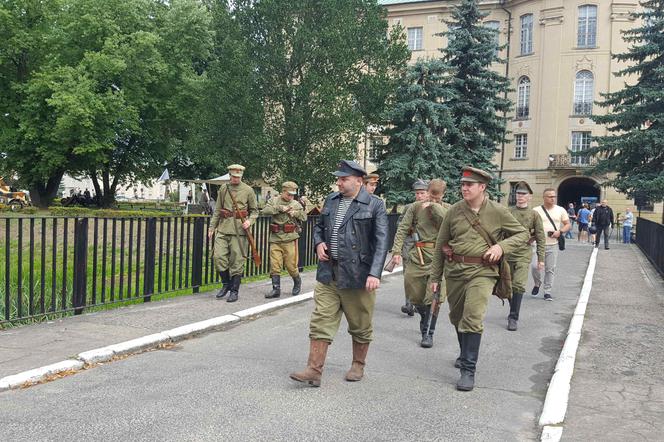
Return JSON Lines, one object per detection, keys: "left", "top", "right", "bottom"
{"left": 262, "top": 181, "right": 307, "bottom": 298}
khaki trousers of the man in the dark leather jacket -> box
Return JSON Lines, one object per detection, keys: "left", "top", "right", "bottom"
{"left": 309, "top": 281, "right": 376, "bottom": 344}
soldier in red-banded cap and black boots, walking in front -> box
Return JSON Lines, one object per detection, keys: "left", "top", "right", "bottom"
{"left": 431, "top": 167, "right": 528, "bottom": 391}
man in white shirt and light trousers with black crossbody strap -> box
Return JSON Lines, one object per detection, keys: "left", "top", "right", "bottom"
{"left": 530, "top": 187, "right": 572, "bottom": 301}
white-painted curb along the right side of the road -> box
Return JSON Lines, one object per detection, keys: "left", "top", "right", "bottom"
{"left": 539, "top": 248, "right": 599, "bottom": 442}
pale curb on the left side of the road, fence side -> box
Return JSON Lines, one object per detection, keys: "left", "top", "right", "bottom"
{"left": 0, "top": 267, "right": 403, "bottom": 392}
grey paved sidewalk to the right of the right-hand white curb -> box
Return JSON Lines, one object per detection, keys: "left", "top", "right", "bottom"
{"left": 563, "top": 244, "right": 664, "bottom": 441}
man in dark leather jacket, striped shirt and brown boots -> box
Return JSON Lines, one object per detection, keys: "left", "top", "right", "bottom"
{"left": 290, "top": 160, "right": 388, "bottom": 387}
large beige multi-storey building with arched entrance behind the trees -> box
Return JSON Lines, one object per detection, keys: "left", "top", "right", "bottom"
{"left": 365, "top": 0, "right": 662, "bottom": 220}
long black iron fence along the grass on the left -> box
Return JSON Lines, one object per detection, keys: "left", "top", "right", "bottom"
{"left": 0, "top": 215, "right": 398, "bottom": 325}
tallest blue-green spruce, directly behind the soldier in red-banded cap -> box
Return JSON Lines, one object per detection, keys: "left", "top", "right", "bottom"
{"left": 439, "top": 0, "right": 512, "bottom": 200}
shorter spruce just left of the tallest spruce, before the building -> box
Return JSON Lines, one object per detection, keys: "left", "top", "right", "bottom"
{"left": 379, "top": 59, "right": 454, "bottom": 204}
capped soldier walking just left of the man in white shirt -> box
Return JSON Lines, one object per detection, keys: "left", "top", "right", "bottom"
{"left": 507, "top": 181, "right": 546, "bottom": 331}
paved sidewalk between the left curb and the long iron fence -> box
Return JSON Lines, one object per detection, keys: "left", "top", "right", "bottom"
{"left": 0, "top": 272, "right": 316, "bottom": 379}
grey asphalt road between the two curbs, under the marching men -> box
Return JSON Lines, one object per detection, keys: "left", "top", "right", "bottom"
{"left": 0, "top": 245, "right": 591, "bottom": 441}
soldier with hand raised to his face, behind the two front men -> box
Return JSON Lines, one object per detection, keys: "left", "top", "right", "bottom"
{"left": 392, "top": 179, "right": 449, "bottom": 348}
